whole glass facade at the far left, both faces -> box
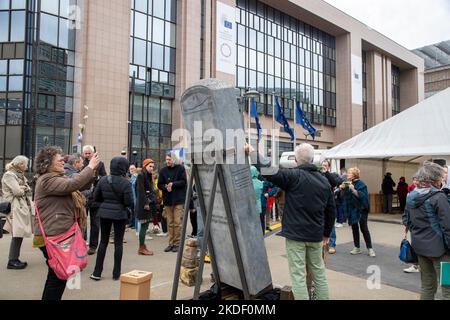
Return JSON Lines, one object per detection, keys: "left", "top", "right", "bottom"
{"left": 0, "top": 0, "right": 76, "bottom": 170}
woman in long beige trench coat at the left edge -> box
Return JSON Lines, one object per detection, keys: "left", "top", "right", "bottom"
{"left": 2, "top": 156, "right": 35, "bottom": 270}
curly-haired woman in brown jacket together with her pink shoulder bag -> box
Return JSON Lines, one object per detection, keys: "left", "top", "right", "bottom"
{"left": 33, "top": 146, "right": 100, "bottom": 300}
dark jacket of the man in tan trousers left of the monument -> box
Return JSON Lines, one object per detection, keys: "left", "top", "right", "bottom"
{"left": 158, "top": 165, "right": 187, "bottom": 206}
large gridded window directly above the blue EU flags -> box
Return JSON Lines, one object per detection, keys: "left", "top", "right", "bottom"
{"left": 236, "top": 0, "right": 336, "bottom": 126}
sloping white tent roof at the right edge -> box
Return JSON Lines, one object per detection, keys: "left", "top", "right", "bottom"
{"left": 322, "top": 88, "right": 450, "bottom": 162}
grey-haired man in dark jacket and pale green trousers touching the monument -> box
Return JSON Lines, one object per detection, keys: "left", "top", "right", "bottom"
{"left": 245, "top": 143, "right": 336, "bottom": 300}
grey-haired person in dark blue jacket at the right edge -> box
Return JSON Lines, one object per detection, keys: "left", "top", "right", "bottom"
{"left": 403, "top": 161, "right": 450, "bottom": 300}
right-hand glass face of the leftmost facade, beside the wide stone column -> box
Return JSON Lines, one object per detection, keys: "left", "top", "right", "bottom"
{"left": 30, "top": 0, "right": 76, "bottom": 152}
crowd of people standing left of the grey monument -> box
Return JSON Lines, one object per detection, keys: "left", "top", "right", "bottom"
{"left": 2, "top": 145, "right": 191, "bottom": 300}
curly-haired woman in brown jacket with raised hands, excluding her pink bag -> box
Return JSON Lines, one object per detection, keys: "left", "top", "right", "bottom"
{"left": 33, "top": 146, "right": 100, "bottom": 300}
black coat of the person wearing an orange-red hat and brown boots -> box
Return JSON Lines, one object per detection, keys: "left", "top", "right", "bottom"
{"left": 135, "top": 169, "right": 157, "bottom": 220}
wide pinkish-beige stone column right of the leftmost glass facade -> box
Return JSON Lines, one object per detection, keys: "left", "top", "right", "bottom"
{"left": 73, "top": 0, "right": 131, "bottom": 170}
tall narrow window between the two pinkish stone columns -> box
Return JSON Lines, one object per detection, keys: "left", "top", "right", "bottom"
{"left": 129, "top": 0, "right": 176, "bottom": 162}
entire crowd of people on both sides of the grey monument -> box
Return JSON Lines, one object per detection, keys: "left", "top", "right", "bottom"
{"left": 2, "top": 144, "right": 450, "bottom": 300}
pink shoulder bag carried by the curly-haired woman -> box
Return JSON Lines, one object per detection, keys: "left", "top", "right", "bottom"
{"left": 34, "top": 200, "right": 88, "bottom": 280}
